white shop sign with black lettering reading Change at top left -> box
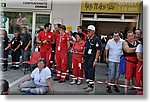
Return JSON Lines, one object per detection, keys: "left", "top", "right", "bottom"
{"left": 0, "top": 0, "right": 52, "bottom": 9}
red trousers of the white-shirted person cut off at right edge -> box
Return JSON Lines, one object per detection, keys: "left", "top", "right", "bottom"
{"left": 135, "top": 61, "right": 143, "bottom": 91}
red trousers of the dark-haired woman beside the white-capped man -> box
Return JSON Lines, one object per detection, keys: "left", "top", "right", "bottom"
{"left": 72, "top": 57, "right": 83, "bottom": 79}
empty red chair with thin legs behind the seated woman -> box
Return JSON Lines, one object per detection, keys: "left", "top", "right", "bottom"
{"left": 22, "top": 52, "right": 41, "bottom": 74}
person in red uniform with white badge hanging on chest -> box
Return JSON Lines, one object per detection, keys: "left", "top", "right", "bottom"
{"left": 54, "top": 25, "right": 70, "bottom": 83}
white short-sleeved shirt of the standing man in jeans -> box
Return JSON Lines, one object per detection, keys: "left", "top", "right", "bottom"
{"left": 105, "top": 38, "right": 124, "bottom": 62}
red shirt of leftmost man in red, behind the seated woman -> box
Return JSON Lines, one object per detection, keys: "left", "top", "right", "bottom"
{"left": 38, "top": 31, "right": 54, "bottom": 51}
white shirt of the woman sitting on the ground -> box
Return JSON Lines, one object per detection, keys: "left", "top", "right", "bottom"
{"left": 31, "top": 67, "right": 51, "bottom": 86}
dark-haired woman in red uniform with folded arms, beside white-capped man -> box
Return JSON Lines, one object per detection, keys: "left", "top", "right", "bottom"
{"left": 70, "top": 33, "right": 85, "bottom": 85}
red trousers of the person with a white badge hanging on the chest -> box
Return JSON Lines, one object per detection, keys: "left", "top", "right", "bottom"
{"left": 56, "top": 51, "right": 68, "bottom": 81}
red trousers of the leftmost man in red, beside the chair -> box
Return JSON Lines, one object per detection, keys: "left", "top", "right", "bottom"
{"left": 40, "top": 49, "right": 52, "bottom": 68}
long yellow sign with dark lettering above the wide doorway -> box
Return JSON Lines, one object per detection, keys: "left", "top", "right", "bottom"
{"left": 81, "top": 0, "right": 142, "bottom": 13}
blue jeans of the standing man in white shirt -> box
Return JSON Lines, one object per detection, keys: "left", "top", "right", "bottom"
{"left": 108, "top": 61, "right": 120, "bottom": 81}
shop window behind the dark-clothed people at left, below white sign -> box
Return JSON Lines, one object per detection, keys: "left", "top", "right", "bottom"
{"left": 2, "top": 12, "right": 32, "bottom": 38}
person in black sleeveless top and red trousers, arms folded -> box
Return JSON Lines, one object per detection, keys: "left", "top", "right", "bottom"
{"left": 122, "top": 30, "right": 139, "bottom": 94}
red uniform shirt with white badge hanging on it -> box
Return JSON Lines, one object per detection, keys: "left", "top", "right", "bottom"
{"left": 56, "top": 33, "right": 70, "bottom": 52}
